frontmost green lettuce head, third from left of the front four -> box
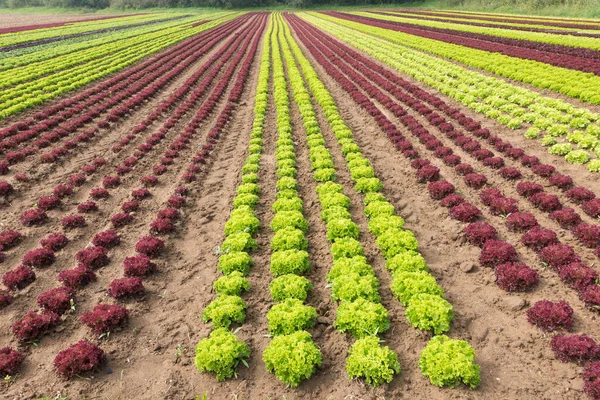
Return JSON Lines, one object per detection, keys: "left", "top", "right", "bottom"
{"left": 346, "top": 336, "right": 400, "bottom": 386}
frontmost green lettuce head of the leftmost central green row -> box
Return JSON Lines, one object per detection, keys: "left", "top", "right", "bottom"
{"left": 195, "top": 328, "right": 250, "bottom": 381}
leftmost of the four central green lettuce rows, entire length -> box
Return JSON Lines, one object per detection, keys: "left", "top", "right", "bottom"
{"left": 195, "top": 12, "right": 272, "bottom": 381}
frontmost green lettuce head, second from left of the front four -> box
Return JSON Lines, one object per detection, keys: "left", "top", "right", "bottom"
{"left": 263, "top": 331, "right": 323, "bottom": 387}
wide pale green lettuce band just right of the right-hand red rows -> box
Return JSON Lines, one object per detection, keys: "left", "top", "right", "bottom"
{"left": 304, "top": 11, "right": 600, "bottom": 172}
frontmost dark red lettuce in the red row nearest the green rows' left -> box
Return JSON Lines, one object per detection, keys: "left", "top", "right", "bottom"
{"left": 54, "top": 339, "right": 105, "bottom": 379}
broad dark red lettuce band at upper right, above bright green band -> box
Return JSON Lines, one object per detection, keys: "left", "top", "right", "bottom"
{"left": 325, "top": 11, "right": 600, "bottom": 75}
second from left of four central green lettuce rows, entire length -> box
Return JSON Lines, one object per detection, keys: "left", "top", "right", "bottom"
{"left": 263, "top": 18, "right": 323, "bottom": 387}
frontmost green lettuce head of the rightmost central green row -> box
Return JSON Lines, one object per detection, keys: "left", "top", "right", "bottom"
{"left": 419, "top": 335, "right": 481, "bottom": 389}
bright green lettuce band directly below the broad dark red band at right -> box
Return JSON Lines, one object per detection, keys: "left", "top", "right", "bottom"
{"left": 321, "top": 12, "right": 600, "bottom": 104}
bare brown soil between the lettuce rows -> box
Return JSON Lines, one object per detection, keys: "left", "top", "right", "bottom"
{"left": 0, "top": 12, "right": 600, "bottom": 400}
